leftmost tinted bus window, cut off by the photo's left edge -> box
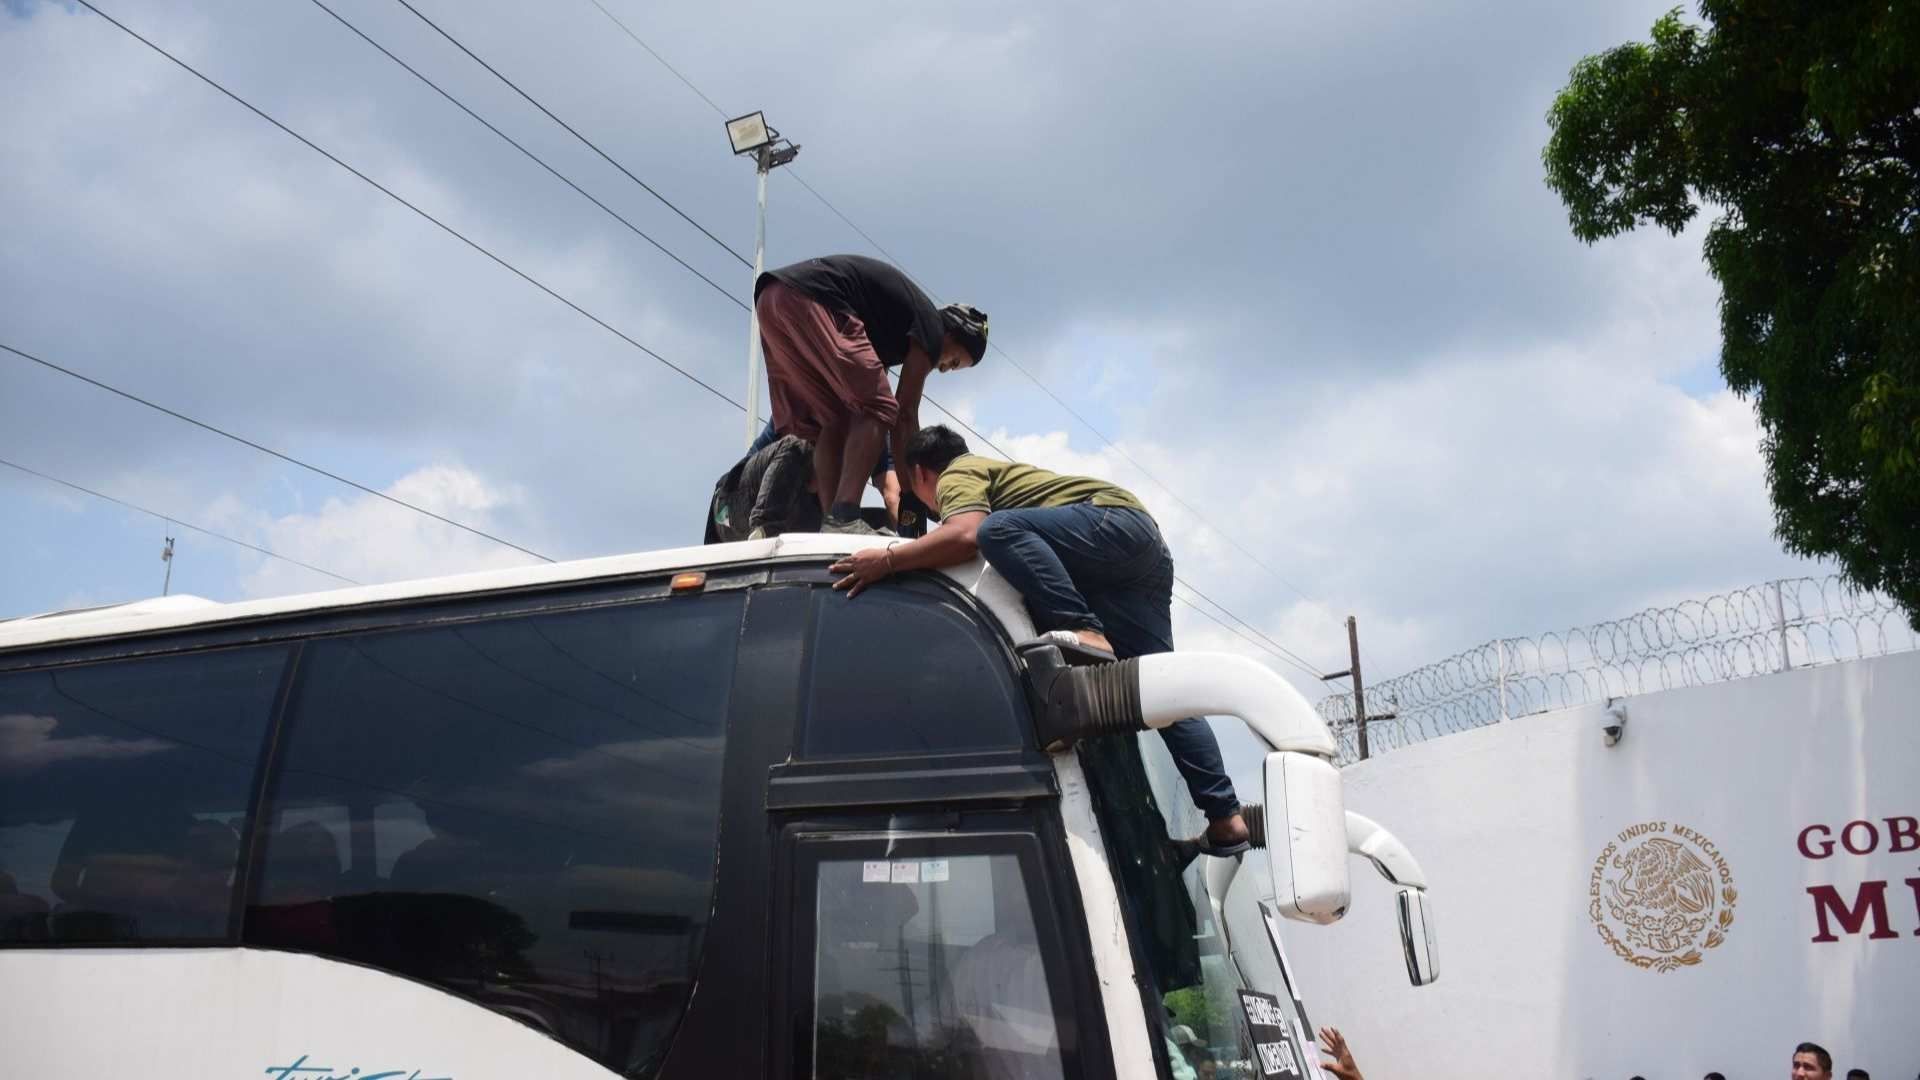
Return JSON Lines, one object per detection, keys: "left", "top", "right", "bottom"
{"left": 0, "top": 648, "right": 286, "bottom": 944}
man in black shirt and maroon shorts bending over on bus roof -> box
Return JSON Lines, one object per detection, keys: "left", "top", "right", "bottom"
{"left": 753, "top": 256, "right": 987, "bottom": 532}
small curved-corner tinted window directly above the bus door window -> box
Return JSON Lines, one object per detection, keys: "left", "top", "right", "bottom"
{"left": 803, "top": 584, "right": 1031, "bottom": 757}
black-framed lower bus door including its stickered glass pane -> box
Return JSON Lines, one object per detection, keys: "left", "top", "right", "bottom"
{"left": 780, "top": 813, "right": 1102, "bottom": 1080}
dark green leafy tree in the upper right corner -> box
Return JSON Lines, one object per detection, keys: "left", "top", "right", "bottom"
{"left": 1542, "top": 0, "right": 1920, "bottom": 628}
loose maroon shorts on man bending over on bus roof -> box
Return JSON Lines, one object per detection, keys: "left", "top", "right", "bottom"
{"left": 753, "top": 281, "right": 900, "bottom": 442}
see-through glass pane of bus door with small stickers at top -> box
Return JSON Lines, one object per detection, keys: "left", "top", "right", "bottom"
{"left": 795, "top": 842, "right": 1073, "bottom": 1080}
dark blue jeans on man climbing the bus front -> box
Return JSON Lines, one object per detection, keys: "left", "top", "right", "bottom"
{"left": 977, "top": 503, "right": 1240, "bottom": 821}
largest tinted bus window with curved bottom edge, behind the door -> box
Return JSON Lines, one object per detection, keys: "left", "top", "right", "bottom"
{"left": 246, "top": 594, "right": 743, "bottom": 1074}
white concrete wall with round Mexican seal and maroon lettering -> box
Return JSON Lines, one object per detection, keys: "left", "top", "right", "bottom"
{"left": 1286, "top": 653, "right": 1920, "bottom": 1080}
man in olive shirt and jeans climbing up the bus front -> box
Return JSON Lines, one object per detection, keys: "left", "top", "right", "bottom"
{"left": 833, "top": 425, "right": 1248, "bottom": 855}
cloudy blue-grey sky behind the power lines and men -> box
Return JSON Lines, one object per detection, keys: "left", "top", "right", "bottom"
{"left": 0, "top": 0, "right": 1822, "bottom": 707}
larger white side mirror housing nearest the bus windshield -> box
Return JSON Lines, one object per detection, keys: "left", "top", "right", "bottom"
{"left": 1265, "top": 749, "right": 1352, "bottom": 924}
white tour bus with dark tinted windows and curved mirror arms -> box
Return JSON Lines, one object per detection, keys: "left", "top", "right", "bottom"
{"left": 0, "top": 536, "right": 1434, "bottom": 1080}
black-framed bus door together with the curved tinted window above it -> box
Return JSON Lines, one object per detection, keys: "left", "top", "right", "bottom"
{"left": 764, "top": 575, "right": 1133, "bottom": 1080}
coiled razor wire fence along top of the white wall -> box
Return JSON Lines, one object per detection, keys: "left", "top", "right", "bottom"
{"left": 1319, "top": 577, "right": 1920, "bottom": 761}
